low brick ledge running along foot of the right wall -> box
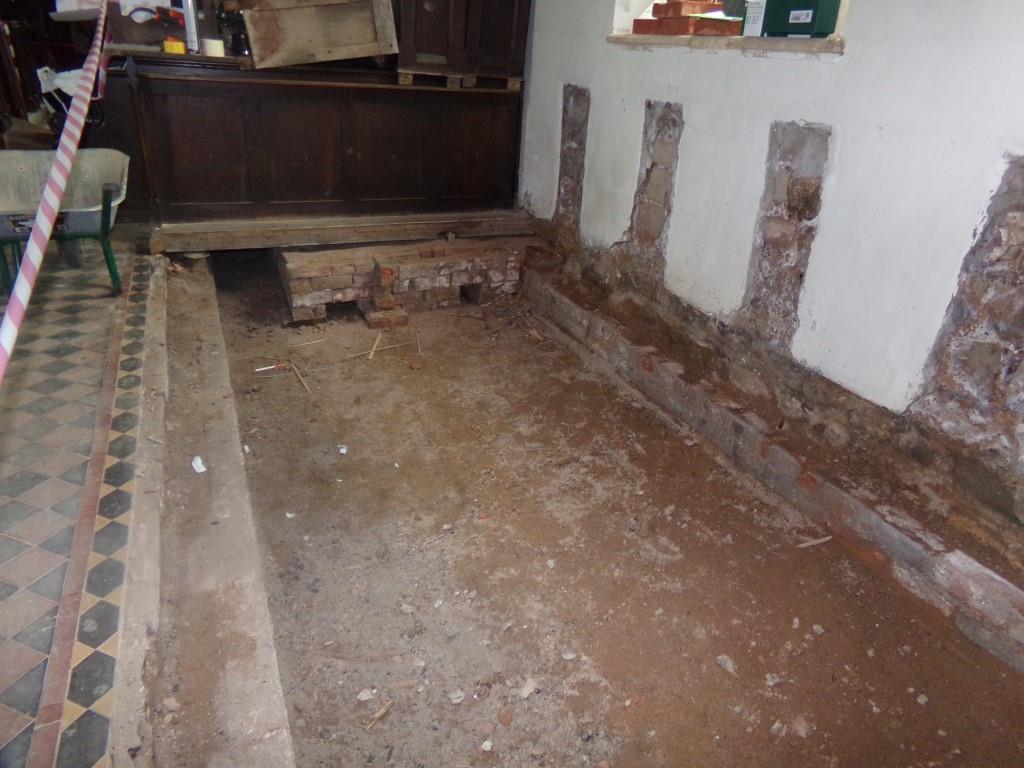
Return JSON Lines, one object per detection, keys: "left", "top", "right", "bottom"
{"left": 523, "top": 271, "right": 1024, "bottom": 672}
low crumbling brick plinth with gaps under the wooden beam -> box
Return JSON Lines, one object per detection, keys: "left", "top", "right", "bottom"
{"left": 276, "top": 238, "right": 544, "bottom": 326}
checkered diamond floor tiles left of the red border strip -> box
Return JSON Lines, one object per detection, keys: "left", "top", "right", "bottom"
{"left": 0, "top": 252, "right": 124, "bottom": 768}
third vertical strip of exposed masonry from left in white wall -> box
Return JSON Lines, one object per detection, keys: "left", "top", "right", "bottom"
{"left": 739, "top": 123, "right": 831, "bottom": 349}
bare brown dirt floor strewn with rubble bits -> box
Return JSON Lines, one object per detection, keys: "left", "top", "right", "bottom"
{"left": 188, "top": 249, "right": 1024, "bottom": 768}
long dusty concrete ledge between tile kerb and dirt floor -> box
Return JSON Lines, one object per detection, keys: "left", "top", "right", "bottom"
{"left": 148, "top": 261, "right": 295, "bottom": 768}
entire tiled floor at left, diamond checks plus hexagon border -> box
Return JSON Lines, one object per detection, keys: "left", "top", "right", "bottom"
{"left": 0, "top": 250, "right": 148, "bottom": 768}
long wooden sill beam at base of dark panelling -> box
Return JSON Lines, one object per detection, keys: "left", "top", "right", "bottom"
{"left": 150, "top": 211, "right": 535, "bottom": 253}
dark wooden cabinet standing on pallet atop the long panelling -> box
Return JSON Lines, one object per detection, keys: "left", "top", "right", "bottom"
{"left": 398, "top": 0, "right": 529, "bottom": 78}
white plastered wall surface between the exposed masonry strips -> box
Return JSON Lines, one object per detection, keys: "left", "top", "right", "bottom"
{"left": 520, "top": 0, "right": 1024, "bottom": 411}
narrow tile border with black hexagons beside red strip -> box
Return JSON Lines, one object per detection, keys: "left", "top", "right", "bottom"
{"left": 21, "top": 256, "right": 152, "bottom": 768}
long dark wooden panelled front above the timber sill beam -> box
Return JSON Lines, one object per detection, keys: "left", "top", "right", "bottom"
{"left": 90, "top": 61, "right": 521, "bottom": 222}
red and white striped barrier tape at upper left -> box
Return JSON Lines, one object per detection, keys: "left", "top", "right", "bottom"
{"left": 0, "top": 0, "right": 106, "bottom": 385}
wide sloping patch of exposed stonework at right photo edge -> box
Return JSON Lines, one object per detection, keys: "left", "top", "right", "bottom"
{"left": 911, "top": 157, "right": 1024, "bottom": 522}
